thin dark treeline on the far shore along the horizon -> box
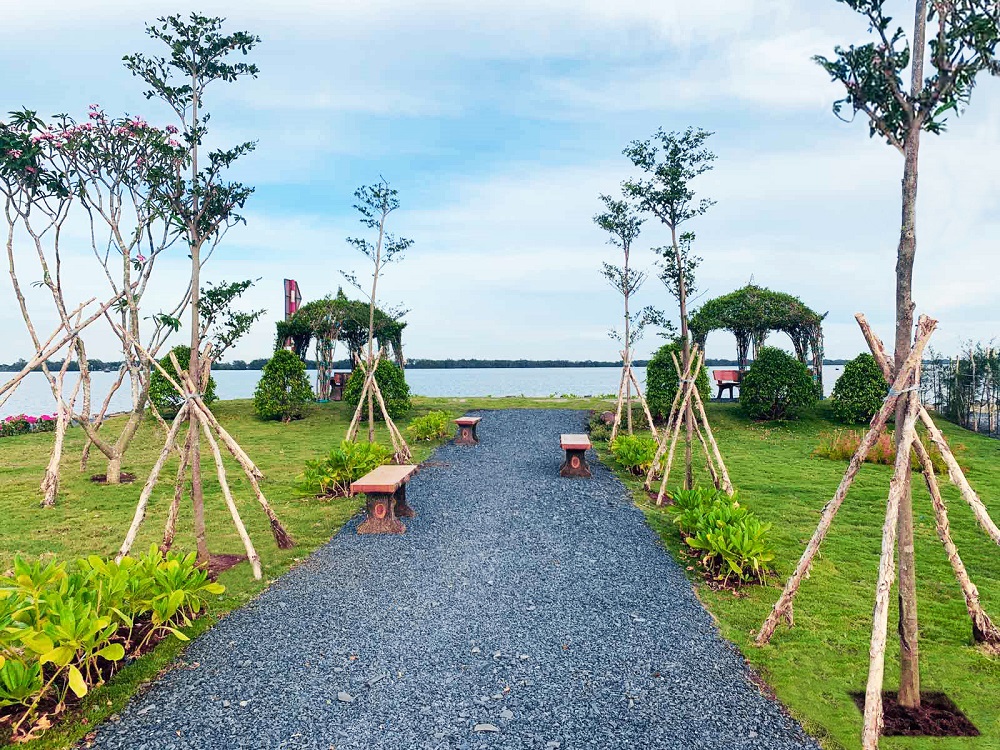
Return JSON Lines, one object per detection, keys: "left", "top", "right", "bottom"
{"left": 0, "top": 358, "right": 860, "bottom": 372}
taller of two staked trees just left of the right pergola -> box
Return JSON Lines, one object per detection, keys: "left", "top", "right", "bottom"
{"left": 622, "top": 128, "right": 715, "bottom": 488}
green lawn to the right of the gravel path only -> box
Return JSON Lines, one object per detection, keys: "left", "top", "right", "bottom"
{"left": 600, "top": 404, "right": 1000, "bottom": 750}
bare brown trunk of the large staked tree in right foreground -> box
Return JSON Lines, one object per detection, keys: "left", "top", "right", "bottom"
{"left": 895, "top": 0, "right": 927, "bottom": 708}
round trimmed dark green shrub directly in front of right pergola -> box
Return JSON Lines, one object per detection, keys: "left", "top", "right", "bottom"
{"left": 740, "top": 346, "right": 817, "bottom": 420}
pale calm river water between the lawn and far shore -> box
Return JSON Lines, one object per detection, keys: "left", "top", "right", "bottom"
{"left": 0, "top": 365, "right": 843, "bottom": 418}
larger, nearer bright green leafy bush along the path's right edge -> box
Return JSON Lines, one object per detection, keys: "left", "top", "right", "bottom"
{"left": 669, "top": 487, "right": 774, "bottom": 583}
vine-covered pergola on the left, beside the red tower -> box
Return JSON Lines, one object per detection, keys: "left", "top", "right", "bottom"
{"left": 275, "top": 289, "right": 406, "bottom": 400}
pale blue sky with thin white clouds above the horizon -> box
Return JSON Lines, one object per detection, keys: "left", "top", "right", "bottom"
{"left": 0, "top": 0, "right": 1000, "bottom": 361}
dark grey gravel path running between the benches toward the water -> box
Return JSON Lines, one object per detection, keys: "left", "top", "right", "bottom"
{"left": 95, "top": 410, "right": 817, "bottom": 750}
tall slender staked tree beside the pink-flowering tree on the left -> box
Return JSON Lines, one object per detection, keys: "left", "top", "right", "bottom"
{"left": 124, "top": 13, "right": 260, "bottom": 563}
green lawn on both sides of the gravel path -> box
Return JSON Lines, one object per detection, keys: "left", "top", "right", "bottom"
{"left": 0, "top": 398, "right": 1000, "bottom": 750}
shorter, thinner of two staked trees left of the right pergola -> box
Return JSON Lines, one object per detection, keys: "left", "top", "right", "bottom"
{"left": 594, "top": 195, "right": 663, "bottom": 439}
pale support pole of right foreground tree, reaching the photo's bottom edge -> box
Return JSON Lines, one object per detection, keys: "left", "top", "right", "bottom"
{"left": 861, "top": 384, "right": 919, "bottom": 750}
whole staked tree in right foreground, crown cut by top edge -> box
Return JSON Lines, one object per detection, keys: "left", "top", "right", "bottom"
{"left": 815, "top": 0, "right": 1000, "bottom": 724}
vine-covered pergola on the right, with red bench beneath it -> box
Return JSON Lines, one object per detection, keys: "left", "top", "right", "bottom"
{"left": 689, "top": 284, "right": 826, "bottom": 394}
